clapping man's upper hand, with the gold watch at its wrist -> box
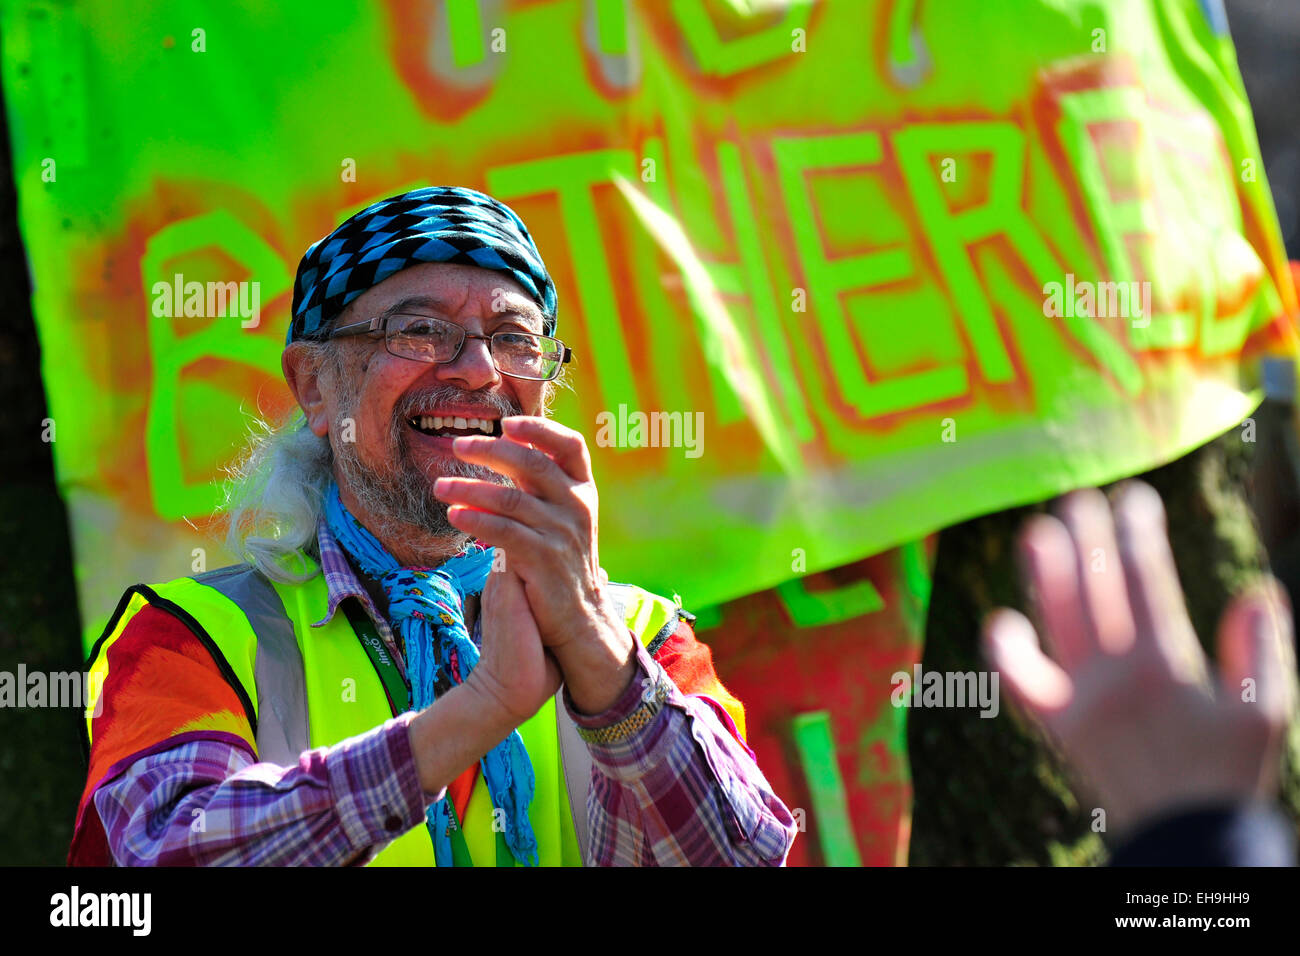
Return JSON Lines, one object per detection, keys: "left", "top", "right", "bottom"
{"left": 434, "top": 416, "right": 636, "bottom": 714}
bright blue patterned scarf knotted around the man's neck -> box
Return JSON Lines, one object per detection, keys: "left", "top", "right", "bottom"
{"left": 325, "top": 485, "right": 537, "bottom": 866}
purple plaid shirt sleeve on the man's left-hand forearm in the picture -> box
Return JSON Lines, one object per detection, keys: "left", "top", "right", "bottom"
{"left": 94, "top": 713, "right": 432, "bottom": 866}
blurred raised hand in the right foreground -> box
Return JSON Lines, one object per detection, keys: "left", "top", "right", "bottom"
{"left": 984, "top": 483, "right": 1295, "bottom": 834}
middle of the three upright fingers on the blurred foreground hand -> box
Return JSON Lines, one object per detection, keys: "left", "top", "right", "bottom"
{"left": 1057, "top": 488, "right": 1135, "bottom": 654}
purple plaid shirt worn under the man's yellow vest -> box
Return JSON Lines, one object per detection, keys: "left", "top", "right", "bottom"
{"left": 94, "top": 522, "right": 796, "bottom": 866}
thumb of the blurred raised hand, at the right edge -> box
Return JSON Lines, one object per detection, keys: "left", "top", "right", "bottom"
{"left": 1218, "top": 578, "right": 1296, "bottom": 727}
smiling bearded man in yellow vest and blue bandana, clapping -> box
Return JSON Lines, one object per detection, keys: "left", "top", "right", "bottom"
{"left": 69, "top": 187, "right": 794, "bottom": 866}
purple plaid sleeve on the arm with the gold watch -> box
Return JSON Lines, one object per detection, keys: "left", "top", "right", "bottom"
{"left": 564, "top": 643, "right": 798, "bottom": 866}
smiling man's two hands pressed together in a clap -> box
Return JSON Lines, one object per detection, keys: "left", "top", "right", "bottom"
{"left": 434, "top": 416, "right": 636, "bottom": 726}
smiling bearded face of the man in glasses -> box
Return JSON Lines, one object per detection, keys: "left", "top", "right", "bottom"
{"left": 312, "top": 263, "right": 550, "bottom": 536}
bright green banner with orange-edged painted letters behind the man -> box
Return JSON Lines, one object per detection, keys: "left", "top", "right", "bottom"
{"left": 3, "top": 0, "right": 1296, "bottom": 647}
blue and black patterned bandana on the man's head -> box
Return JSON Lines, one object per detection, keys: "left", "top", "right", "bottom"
{"left": 285, "top": 186, "right": 556, "bottom": 345}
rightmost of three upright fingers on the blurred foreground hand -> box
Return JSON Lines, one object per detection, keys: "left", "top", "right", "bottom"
{"left": 1114, "top": 481, "right": 1205, "bottom": 683}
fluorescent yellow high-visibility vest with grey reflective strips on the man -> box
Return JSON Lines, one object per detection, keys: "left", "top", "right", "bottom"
{"left": 101, "top": 564, "right": 677, "bottom": 866}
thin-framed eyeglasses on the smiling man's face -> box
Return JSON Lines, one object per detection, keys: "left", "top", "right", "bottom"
{"left": 329, "top": 312, "right": 573, "bottom": 381}
